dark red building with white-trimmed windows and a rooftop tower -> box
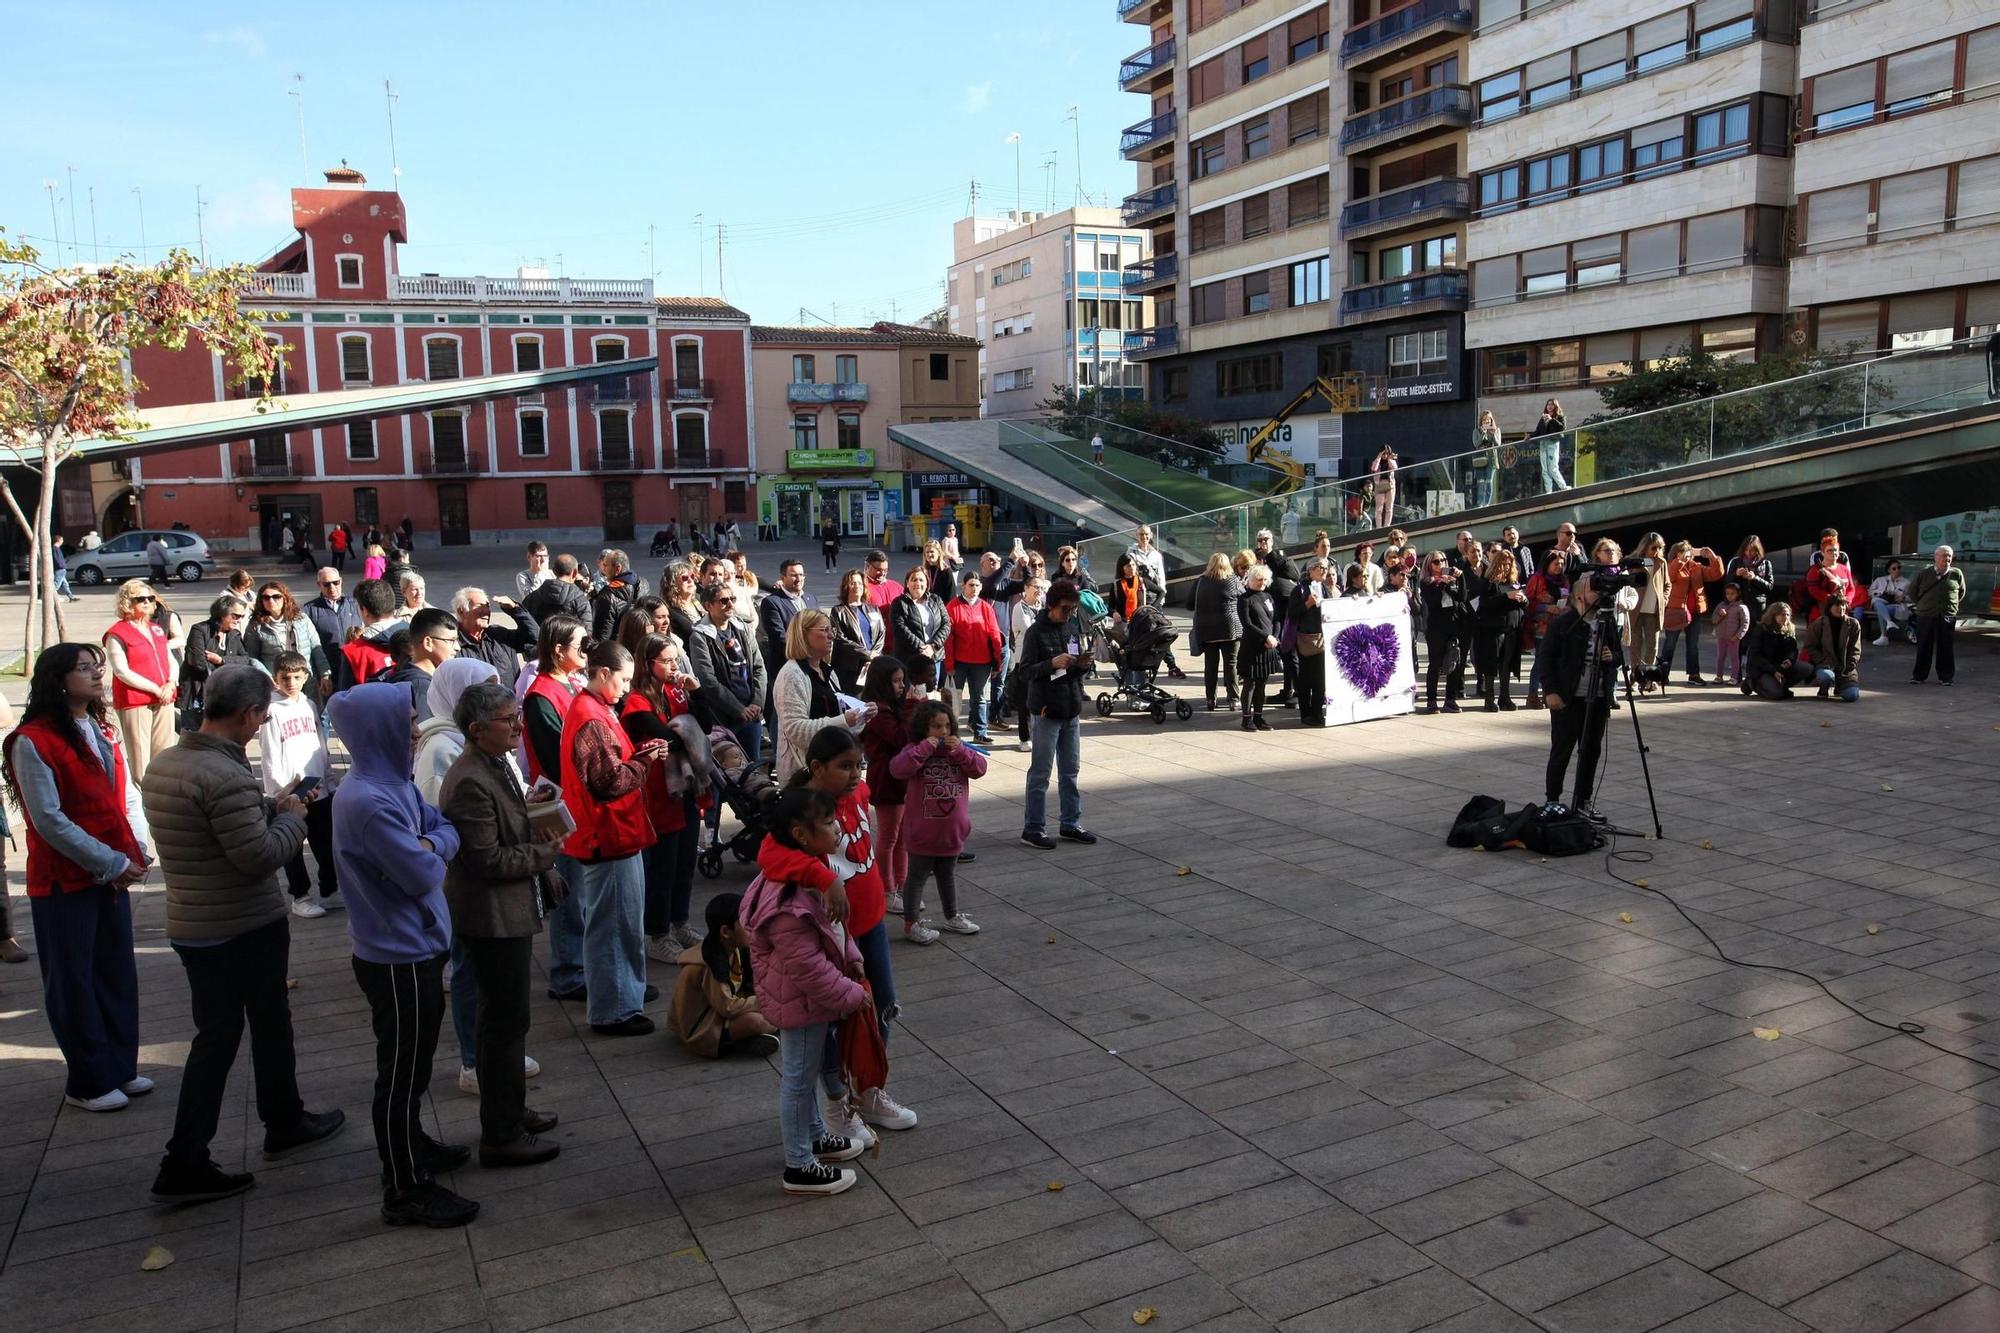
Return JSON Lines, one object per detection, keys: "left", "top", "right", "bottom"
{"left": 121, "top": 168, "right": 754, "bottom": 548}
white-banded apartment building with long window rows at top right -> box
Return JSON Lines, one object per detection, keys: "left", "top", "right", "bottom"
{"left": 1466, "top": 0, "right": 2000, "bottom": 434}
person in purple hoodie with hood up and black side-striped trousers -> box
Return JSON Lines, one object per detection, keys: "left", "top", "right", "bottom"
{"left": 326, "top": 683, "right": 480, "bottom": 1227}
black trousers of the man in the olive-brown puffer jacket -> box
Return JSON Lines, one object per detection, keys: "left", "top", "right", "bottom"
{"left": 166, "top": 917, "right": 306, "bottom": 1171}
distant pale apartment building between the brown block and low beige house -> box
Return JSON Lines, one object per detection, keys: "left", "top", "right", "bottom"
{"left": 944, "top": 208, "right": 1152, "bottom": 416}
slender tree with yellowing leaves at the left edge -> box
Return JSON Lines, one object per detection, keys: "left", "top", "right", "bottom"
{"left": 0, "top": 230, "right": 286, "bottom": 662}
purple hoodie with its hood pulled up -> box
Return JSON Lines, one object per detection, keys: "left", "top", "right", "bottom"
{"left": 326, "top": 685, "right": 458, "bottom": 963}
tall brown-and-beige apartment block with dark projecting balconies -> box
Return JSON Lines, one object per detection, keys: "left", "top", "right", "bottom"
{"left": 1118, "top": 0, "right": 1474, "bottom": 474}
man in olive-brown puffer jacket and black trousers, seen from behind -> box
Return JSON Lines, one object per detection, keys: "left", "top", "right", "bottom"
{"left": 142, "top": 667, "right": 344, "bottom": 1203}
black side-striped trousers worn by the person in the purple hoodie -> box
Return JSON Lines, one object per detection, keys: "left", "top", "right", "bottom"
{"left": 354, "top": 953, "right": 446, "bottom": 1193}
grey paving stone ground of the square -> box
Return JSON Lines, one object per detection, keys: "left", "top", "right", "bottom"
{"left": 0, "top": 548, "right": 2000, "bottom": 1333}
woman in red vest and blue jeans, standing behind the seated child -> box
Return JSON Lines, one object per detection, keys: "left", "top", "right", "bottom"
{"left": 562, "top": 642, "right": 666, "bottom": 1037}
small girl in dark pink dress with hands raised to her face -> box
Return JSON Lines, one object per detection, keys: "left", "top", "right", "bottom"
{"left": 890, "top": 703, "right": 986, "bottom": 945}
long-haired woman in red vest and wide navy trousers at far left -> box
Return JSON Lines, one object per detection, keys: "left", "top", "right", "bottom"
{"left": 4, "top": 640, "right": 152, "bottom": 1111}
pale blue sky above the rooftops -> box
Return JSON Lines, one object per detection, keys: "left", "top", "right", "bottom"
{"left": 0, "top": 0, "right": 1146, "bottom": 322}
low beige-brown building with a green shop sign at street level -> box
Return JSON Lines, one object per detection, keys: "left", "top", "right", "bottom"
{"left": 750, "top": 322, "right": 980, "bottom": 540}
